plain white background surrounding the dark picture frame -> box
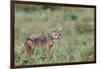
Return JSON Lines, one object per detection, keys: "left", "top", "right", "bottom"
{"left": 0, "top": 0, "right": 100, "bottom": 69}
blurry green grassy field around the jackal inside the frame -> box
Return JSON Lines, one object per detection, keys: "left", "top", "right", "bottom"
{"left": 15, "top": 5, "right": 94, "bottom": 65}
